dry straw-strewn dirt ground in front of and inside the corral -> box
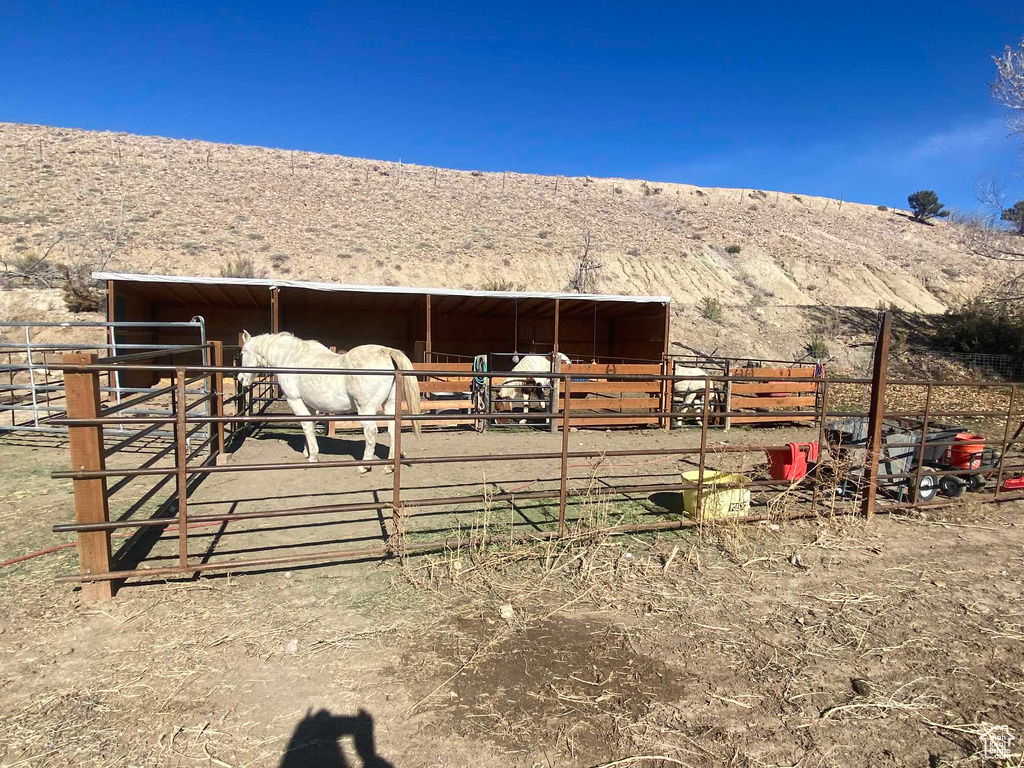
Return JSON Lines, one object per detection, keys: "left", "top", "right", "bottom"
{"left": 0, "top": 429, "right": 1024, "bottom": 768}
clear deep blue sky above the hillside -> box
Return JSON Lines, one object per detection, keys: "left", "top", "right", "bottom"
{"left": 0, "top": 0, "right": 1024, "bottom": 208}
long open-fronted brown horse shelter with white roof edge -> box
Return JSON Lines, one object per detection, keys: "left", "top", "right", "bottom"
{"left": 93, "top": 272, "right": 671, "bottom": 362}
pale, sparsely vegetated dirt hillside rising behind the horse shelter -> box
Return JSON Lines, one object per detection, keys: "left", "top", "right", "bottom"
{"left": 0, "top": 123, "right": 1007, "bottom": 364}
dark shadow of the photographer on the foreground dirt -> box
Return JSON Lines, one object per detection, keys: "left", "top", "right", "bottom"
{"left": 279, "top": 710, "right": 394, "bottom": 768}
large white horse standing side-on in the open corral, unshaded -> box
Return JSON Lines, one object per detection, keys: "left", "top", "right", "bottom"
{"left": 239, "top": 331, "right": 420, "bottom": 472}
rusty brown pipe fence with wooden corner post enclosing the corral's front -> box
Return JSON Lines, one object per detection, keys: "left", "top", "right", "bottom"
{"left": 44, "top": 342, "right": 1024, "bottom": 600}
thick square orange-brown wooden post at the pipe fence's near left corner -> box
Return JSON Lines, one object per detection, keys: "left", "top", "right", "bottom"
{"left": 63, "top": 352, "right": 114, "bottom": 603}
